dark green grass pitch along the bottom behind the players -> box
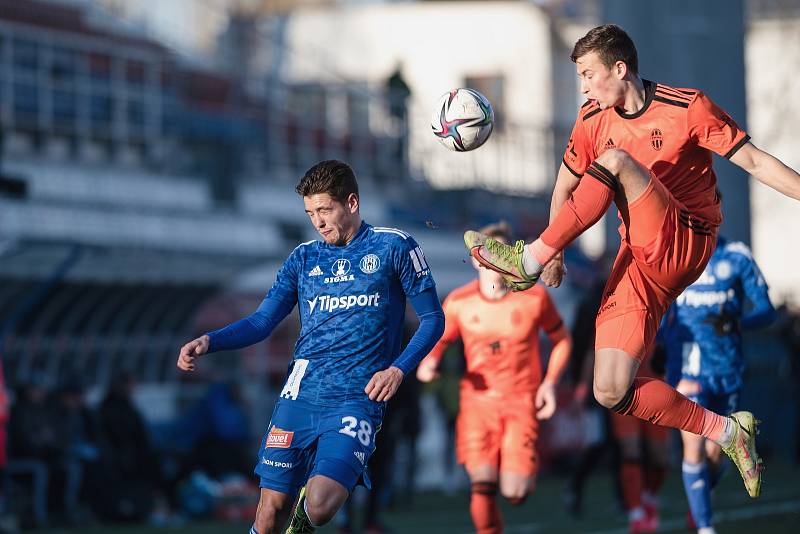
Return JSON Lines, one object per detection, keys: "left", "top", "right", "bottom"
{"left": 29, "top": 464, "right": 800, "bottom": 534}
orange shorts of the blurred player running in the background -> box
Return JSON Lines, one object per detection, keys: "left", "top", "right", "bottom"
{"left": 456, "top": 394, "right": 539, "bottom": 476}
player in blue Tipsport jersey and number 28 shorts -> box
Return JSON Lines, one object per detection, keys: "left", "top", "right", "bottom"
{"left": 178, "top": 160, "right": 444, "bottom": 534}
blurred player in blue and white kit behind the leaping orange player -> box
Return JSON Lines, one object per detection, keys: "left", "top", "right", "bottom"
{"left": 658, "top": 236, "right": 775, "bottom": 534}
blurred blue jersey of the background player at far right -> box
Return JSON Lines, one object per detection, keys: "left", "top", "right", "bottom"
{"left": 658, "top": 237, "right": 775, "bottom": 393}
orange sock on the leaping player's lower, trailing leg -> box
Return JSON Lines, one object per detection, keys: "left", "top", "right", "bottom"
{"left": 611, "top": 377, "right": 726, "bottom": 441}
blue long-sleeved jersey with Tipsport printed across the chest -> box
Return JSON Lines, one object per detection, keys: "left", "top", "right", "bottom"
{"left": 208, "top": 223, "right": 444, "bottom": 405}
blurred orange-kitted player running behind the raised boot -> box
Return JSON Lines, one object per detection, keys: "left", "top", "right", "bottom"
{"left": 417, "top": 223, "right": 572, "bottom": 534}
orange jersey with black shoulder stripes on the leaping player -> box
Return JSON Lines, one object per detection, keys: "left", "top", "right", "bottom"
{"left": 564, "top": 80, "right": 750, "bottom": 226}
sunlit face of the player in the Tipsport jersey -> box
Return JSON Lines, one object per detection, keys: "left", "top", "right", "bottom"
{"left": 303, "top": 193, "right": 360, "bottom": 246}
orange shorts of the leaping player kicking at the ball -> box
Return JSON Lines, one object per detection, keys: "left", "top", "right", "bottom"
{"left": 595, "top": 177, "right": 717, "bottom": 362}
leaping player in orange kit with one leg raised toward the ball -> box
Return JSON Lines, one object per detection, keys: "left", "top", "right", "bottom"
{"left": 464, "top": 24, "right": 800, "bottom": 497}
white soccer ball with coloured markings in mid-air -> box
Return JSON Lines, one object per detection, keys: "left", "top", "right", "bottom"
{"left": 431, "top": 89, "right": 494, "bottom": 152}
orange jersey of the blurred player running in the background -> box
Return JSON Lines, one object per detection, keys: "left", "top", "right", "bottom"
{"left": 429, "top": 280, "right": 563, "bottom": 394}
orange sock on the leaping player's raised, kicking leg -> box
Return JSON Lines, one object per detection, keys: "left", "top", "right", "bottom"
{"left": 531, "top": 162, "right": 617, "bottom": 265}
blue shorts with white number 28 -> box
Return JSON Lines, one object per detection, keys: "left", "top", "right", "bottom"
{"left": 254, "top": 399, "right": 383, "bottom": 495}
